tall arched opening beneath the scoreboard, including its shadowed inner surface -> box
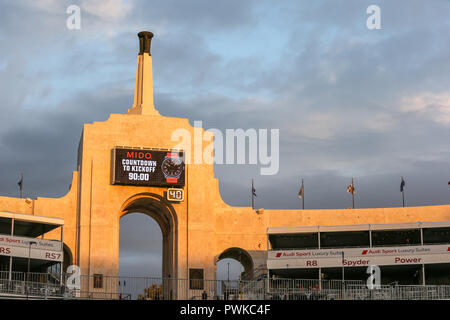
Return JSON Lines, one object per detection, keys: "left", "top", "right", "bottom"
{"left": 119, "top": 193, "right": 177, "bottom": 299}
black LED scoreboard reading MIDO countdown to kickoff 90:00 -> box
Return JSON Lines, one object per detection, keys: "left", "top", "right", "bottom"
{"left": 111, "top": 148, "right": 185, "bottom": 187}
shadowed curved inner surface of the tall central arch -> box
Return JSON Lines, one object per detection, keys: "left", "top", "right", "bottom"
{"left": 118, "top": 193, "right": 178, "bottom": 279}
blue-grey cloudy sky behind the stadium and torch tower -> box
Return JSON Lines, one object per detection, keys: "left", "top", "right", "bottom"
{"left": 0, "top": 0, "right": 450, "bottom": 274}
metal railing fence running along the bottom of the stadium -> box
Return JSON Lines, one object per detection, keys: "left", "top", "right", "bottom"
{"left": 0, "top": 271, "right": 450, "bottom": 300}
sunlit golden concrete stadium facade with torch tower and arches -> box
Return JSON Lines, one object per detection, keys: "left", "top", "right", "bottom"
{"left": 0, "top": 32, "right": 450, "bottom": 297}
